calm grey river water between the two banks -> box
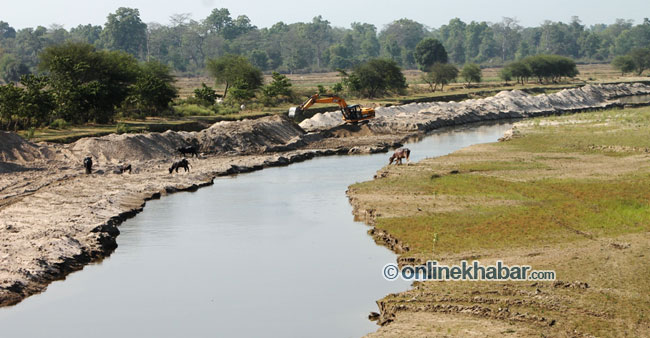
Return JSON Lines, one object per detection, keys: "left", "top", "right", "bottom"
{"left": 0, "top": 124, "right": 510, "bottom": 337}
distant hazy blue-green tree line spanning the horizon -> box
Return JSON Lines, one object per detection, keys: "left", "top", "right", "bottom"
{"left": 0, "top": 7, "right": 650, "bottom": 82}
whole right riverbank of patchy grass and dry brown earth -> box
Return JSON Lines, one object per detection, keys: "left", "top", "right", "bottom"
{"left": 349, "top": 108, "right": 650, "bottom": 338}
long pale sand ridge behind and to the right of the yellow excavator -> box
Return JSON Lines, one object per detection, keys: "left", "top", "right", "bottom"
{"left": 300, "top": 83, "right": 650, "bottom": 133}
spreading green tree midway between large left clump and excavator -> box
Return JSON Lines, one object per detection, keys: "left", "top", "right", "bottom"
{"left": 207, "top": 54, "right": 263, "bottom": 98}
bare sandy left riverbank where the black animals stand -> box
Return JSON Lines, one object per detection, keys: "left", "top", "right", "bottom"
{"left": 0, "top": 85, "right": 650, "bottom": 306}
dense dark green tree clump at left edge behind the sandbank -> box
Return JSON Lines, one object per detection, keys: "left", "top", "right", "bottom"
{"left": 0, "top": 42, "right": 177, "bottom": 130}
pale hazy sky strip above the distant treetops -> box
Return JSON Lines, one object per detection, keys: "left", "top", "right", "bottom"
{"left": 0, "top": 0, "right": 650, "bottom": 29}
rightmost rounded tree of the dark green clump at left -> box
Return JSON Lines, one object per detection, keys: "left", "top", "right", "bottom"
{"left": 126, "top": 61, "right": 178, "bottom": 116}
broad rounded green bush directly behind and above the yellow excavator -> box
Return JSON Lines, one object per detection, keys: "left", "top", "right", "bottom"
{"left": 344, "top": 59, "right": 407, "bottom": 98}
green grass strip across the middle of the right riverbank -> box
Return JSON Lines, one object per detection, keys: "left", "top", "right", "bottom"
{"left": 377, "top": 174, "right": 650, "bottom": 254}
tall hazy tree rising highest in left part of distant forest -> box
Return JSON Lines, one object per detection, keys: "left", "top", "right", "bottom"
{"left": 101, "top": 7, "right": 147, "bottom": 57}
